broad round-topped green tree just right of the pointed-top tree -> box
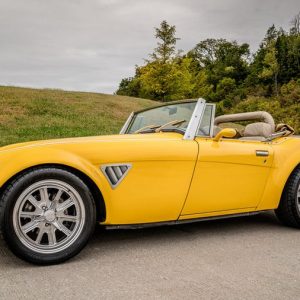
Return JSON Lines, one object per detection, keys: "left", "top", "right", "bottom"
{"left": 187, "top": 39, "right": 250, "bottom": 107}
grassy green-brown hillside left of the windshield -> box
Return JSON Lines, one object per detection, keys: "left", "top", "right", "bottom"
{"left": 0, "top": 86, "right": 157, "bottom": 146}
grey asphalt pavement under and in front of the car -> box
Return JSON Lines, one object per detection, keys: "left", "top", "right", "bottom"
{"left": 0, "top": 213, "right": 300, "bottom": 300}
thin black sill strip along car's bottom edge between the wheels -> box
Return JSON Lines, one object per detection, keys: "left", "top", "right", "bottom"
{"left": 100, "top": 210, "right": 267, "bottom": 229}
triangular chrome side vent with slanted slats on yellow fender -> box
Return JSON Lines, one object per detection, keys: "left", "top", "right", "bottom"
{"left": 101, "top": 164, "right": 131, "bottom": 188}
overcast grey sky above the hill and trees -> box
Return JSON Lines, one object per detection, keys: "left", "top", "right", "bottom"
{"left": 0, "top": 0, "right": 300, "bottom": 93}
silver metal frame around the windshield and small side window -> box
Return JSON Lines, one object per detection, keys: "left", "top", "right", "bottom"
{"left": 119, "top": 98, "right": 215, "bottom": 140}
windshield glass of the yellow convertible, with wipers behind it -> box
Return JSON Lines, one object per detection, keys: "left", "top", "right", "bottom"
{"left": 126, "top": 102, "right": 197, "bottom": 133}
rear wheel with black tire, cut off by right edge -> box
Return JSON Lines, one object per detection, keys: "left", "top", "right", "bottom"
{"left": 275, "top": 167, "right": 300, "bottom": 228}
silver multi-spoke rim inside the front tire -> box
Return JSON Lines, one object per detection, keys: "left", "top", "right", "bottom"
{"left": 13, "top": 179, "right": 85, "bottom": 254}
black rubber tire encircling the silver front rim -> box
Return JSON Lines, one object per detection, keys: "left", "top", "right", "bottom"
{"left": 0, "top": 167, "right": 96, "bottom": 265}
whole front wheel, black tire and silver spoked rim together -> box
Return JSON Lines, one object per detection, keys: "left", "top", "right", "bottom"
{"left": 1, "top": 168, "right": 96, "bottom": 264}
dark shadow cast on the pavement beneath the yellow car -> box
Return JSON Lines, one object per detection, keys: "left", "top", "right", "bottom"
{"left": 0, "top": 212, "right": 293, "bottom": 269}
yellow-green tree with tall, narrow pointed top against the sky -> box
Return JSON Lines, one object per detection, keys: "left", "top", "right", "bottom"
{"left": 117, "top": 21, "right": 193, "bottom": 101}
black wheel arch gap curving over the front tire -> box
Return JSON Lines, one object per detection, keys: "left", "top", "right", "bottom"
{"left": 0, "top": 163, "right": 106, "bottom": 222}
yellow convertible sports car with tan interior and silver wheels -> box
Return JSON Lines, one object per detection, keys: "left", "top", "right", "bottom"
{"left": 0, "top": 99, "right": 300, "bottom": 264}
